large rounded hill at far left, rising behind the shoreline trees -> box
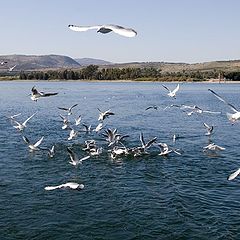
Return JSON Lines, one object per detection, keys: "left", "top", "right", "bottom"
{"left": 0, "top": 55, "right": 81, "bottom": 71}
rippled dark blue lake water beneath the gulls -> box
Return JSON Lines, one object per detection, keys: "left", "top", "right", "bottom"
{"left": 0, "top": 82, "right": 240, "bottom": 240}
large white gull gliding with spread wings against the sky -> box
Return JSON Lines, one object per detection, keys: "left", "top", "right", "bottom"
{"left": 68, "top": 24, "right": 137, "bottom": 37}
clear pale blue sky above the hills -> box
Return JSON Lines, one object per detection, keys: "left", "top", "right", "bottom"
{"left": 0, "top": 0, "right": 240, "bottom": 63}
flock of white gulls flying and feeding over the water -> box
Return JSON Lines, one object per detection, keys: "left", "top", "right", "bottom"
{"left": 7, "top": 84, "right": 240, "bottom": 191}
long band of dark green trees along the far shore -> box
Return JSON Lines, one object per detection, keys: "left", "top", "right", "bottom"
{"left": 19, "top": 65, "right": 240, "bottom": 81}
